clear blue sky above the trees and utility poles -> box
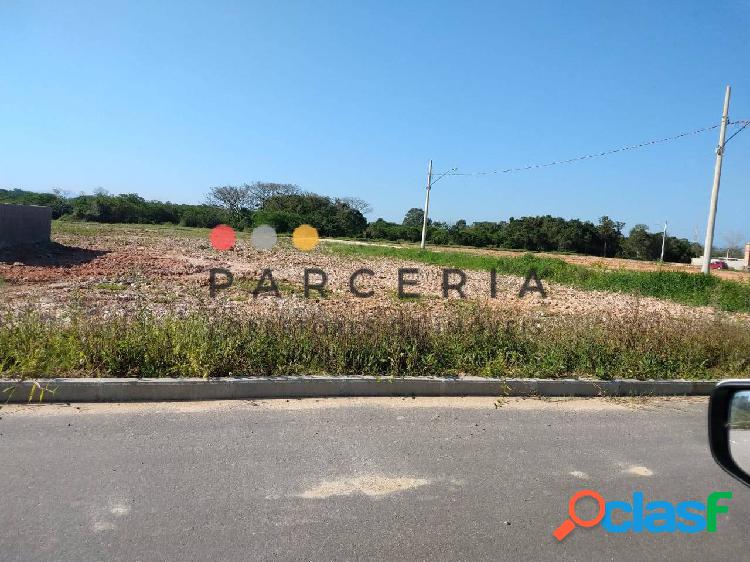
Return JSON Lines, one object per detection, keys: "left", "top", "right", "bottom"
{"left": 0, "top": 0, "right": 750, "bottom": 241}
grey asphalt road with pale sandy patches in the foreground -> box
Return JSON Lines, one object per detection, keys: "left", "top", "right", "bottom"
{"left": 0, "top": 398, "right": 750, "bottom": 562}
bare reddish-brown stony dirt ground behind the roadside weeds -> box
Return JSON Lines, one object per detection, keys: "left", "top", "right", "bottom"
{"left": 0, "top": 223, "right": 750, "bottom": 322}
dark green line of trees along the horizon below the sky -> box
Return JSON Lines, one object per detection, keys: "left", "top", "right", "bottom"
{"left": 0, "top": 182, "right": 702, "bottom": 262}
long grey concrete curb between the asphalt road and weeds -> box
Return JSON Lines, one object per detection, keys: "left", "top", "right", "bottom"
{"left": 0, "top": 377, "right": 716, "bottom": 403}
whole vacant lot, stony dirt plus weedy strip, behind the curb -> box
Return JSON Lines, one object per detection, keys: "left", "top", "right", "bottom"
{"left": 0, "top": 224, "right": 750, "bottom": 379}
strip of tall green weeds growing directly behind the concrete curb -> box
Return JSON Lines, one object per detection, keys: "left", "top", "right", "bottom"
{"left": 0, "top": 309, "right": 750, "bottom": 379}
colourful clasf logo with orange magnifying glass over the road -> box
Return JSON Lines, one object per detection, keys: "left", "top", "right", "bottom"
{"left": 552, "top": 490, "right": 732, "bottom": 541}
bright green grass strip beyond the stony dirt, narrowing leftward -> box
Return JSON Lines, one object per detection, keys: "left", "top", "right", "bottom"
{"left": 326, "top": 243, "right": 750, "bottom": 312}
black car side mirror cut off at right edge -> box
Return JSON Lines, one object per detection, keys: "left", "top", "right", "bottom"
{"left": 708, "top": 380, "right": 750, "bottom": 486}
